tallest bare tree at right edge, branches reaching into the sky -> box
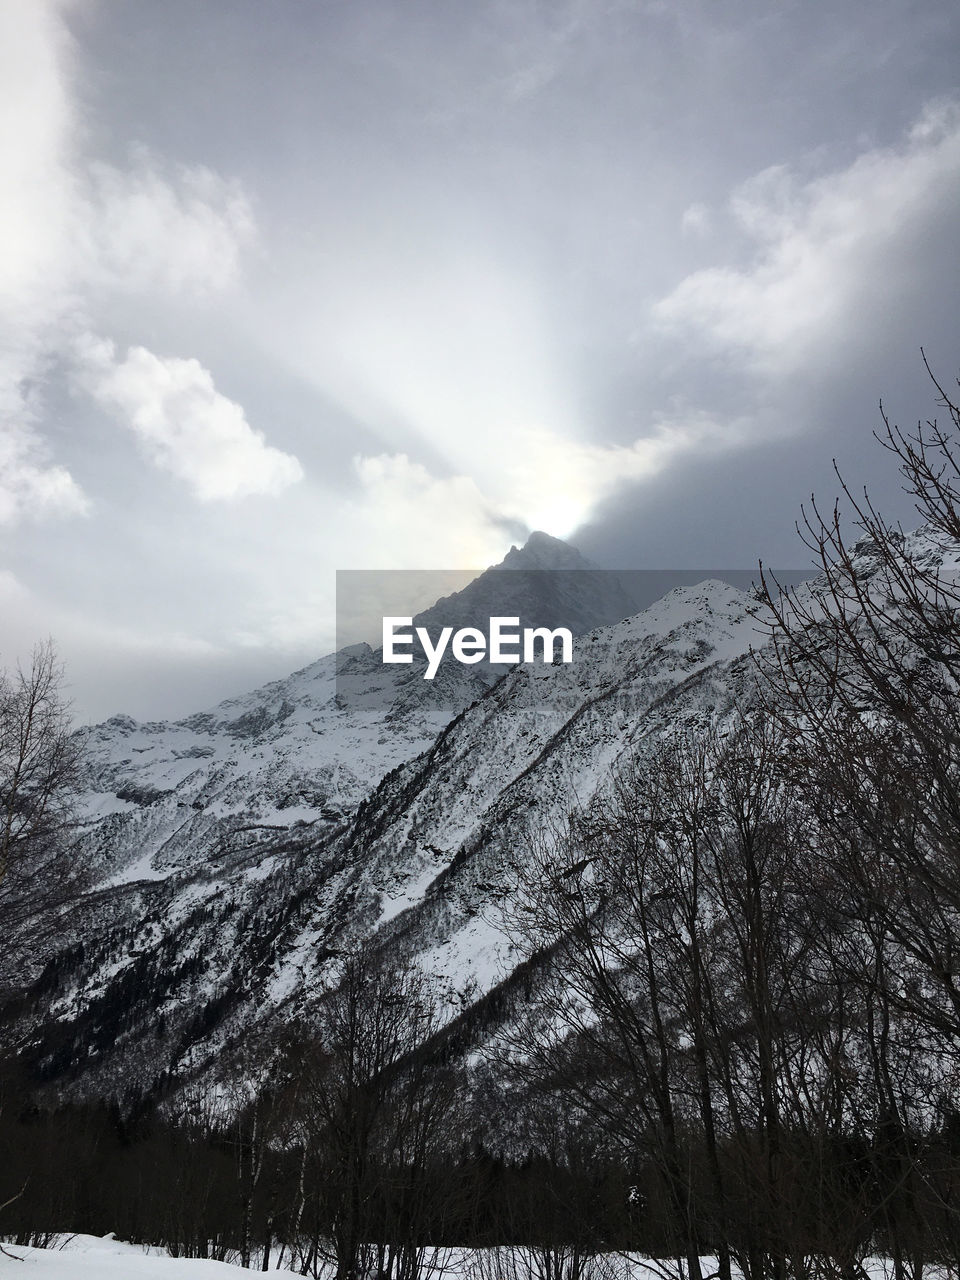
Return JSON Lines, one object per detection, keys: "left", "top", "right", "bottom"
{"left": 760, "top": 358, "right": 960, "bottom": 1277}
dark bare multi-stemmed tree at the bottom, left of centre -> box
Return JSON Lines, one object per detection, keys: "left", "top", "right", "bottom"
{"left": 291, "top": 943, "right": 456, "bottom": 1280}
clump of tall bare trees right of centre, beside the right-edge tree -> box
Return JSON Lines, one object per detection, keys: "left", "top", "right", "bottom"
{"left": 507, "top": 713, "right": 890, "bottom": 1280}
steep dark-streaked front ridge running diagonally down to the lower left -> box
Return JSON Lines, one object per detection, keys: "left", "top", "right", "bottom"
{"left": 24, "top": 570, "right": 758, "bottom": 1097}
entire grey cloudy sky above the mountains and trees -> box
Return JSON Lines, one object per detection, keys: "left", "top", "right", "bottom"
{"left": 0, "top": 0, "right": 960, "bottom": 718}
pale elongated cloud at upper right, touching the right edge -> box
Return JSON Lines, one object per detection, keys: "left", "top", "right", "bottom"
{"left": 653, "top": 102, "right": 960, "bottom": 372}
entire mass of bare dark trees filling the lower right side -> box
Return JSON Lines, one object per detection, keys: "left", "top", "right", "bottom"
{"left": 499, "top": 360, "right": 960, "bottom": 1280}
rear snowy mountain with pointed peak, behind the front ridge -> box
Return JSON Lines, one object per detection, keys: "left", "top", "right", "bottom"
{"left": 71, "top": 532, "right": 631, "bottom": 886}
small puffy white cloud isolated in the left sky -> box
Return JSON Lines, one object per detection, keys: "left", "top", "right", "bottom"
{"left": 77, "top": 337, "right": 303, "bottom": 502}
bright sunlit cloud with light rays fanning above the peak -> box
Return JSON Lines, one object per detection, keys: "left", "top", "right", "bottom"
{"left": 278, "top": 250, "right": 732, "bottom": 540}
